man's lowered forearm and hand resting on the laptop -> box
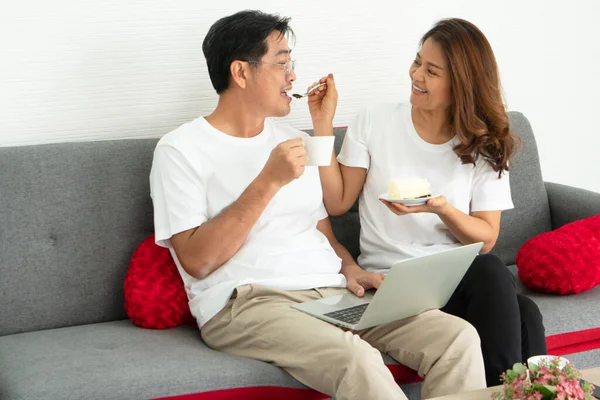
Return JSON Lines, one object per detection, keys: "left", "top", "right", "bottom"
{"left": 317, "top": 218, "right": 384, "bottom": 297}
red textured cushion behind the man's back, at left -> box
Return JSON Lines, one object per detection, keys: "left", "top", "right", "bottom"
{"left": 124, "top": 235, "right": 194, "bottom": 329}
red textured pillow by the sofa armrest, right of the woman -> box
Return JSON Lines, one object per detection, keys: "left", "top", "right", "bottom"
{"left": 517, "top": 214, "right": 600, "bottom": 294}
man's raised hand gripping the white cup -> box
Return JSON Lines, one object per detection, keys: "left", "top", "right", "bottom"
{"left": 260, "top": 138, "right": 306, "bottom": 187}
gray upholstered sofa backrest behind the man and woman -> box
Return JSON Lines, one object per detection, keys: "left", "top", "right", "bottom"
{"left": 0, "top": 113, "right": 550, "bottom": 335}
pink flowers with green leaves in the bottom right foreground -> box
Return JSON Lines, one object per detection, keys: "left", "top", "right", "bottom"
{"left": 492, "top": 357, "right": 594, "bottom": 400}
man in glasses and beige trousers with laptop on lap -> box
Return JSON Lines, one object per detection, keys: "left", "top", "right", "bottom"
{"left": 150, "top": 11, "right": 485, "bottom": 400}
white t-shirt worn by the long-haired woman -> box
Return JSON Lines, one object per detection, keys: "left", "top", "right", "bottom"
{"left": 338, "top": 103, "right": 513, "bottom": 272}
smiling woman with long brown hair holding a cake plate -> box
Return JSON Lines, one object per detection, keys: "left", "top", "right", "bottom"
{"left": 309, "top": 19, "right": 546, "bottom": 385}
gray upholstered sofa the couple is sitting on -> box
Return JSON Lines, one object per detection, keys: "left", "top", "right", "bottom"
{"left": 0, "top": 112, "right": 600, "bottom": 400}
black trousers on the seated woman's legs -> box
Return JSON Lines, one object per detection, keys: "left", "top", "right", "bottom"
{"left": 442, "top": 254, "right": 547, "bottom": 386}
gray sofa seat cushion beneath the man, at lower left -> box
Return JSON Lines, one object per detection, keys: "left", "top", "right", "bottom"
{"left": 0, "top": 320, "right": 418, "bottom": 400}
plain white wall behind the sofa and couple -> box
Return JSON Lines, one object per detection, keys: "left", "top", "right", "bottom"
{"left": 0, "top": 0, "right": 600, "bottom": 192}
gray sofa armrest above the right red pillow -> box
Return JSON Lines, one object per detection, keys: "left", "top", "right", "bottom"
{"left": 544, "top": 182, "right": 600, "bottom": 229}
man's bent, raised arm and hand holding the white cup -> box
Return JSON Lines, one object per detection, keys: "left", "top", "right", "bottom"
{"left": 171, "top": 138, "right": 306, "bottom": 279}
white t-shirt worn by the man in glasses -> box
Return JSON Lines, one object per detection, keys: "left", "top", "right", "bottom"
{"left": 150, "top": 117, "right": 346, "bottom": 326}
